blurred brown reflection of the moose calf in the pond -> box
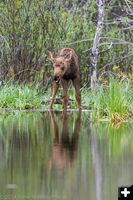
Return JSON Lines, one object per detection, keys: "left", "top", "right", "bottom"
{"left": 50, "top": 111, "right": 81, "bottom": 170}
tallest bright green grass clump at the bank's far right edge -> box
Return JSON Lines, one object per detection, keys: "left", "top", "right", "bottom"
{"left": 105, "top": 77, "right": 133, "bottom": 120}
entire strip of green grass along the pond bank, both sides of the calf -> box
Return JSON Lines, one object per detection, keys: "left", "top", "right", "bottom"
{"left": 0, "top": 76, "right": 133, "bottom": 122}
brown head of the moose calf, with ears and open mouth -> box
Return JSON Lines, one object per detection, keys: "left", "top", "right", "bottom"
{"left": 46, "top": 51, "right": 72, "bottom": 83}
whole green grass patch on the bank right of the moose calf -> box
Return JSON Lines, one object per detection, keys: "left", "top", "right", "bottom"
{"left": 82, "top": 76, "right": 133, "bottom": 122}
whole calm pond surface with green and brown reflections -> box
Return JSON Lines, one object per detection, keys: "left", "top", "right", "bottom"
{"left": 0, "top": 111, "right": 133, "bottom": 200}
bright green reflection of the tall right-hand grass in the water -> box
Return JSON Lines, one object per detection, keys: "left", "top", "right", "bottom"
{"left": 92, "top": 122, "right": 133, "bottom": 159}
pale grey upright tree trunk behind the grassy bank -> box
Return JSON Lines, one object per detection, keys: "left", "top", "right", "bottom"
{"left": 90, "top": 0, "right": 105, "bottom": 90}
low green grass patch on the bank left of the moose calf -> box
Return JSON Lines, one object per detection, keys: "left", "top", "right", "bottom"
{"left": 0, "top": 84, "right": 42, "bottom": 110}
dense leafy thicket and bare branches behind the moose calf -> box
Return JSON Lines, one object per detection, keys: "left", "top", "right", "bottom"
{"left": 0, "top": 0, "right": 133, "bottom": 119}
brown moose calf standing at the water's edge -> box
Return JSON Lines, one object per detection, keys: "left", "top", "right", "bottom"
{"left": 46, "top": 48, "right": 81, "bottom": 110}
